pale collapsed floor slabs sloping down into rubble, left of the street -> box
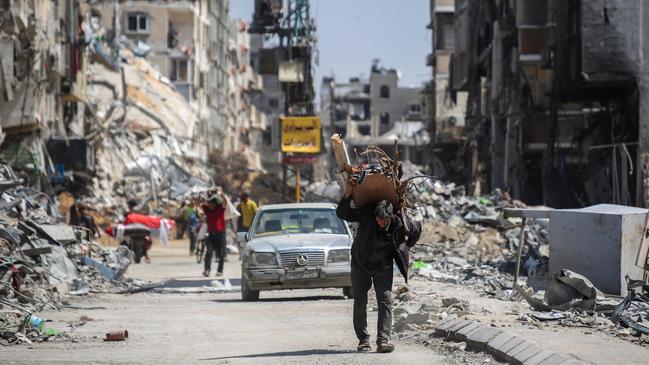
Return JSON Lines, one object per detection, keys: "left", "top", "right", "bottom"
{"left": 86, "top": 39, "right": 210, "bottom": 210}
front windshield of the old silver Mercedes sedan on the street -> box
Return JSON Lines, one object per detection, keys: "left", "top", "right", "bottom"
{"left": 253, "top": 208, "right": 346, "bottom": 237}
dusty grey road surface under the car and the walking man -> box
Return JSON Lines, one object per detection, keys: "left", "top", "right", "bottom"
{"left": 0, "top": 243, "right": 482, "bottom": 364}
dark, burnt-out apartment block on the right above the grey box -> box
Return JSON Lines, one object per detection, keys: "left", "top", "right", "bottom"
{"left": 429, "top": 0, "right": 649, "bottom": 208}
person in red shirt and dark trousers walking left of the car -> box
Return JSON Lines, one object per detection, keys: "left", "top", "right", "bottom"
{"left": 201, "top": 190, "right": 227, "bottom": 277}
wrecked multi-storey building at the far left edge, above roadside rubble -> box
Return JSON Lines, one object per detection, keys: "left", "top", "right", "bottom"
{"left": 0, "top": 0, "right": 92, "bottom": 190}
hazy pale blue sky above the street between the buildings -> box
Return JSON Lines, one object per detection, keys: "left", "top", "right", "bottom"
{"left": 230, "top": 0, "right": 431, "bottom": 90}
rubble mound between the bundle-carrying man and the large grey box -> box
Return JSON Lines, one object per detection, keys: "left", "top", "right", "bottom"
{"left": 394, "top": 162, "right": 549, "bottom": 288}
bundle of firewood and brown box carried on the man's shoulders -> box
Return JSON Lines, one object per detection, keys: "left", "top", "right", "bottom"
{"left": 331, "top": 134, "right": 431, "bottom": 213}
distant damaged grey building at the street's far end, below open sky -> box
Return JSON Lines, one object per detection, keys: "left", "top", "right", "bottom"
{"left": 320, "top": 60, "right": 430, "bottom": 165}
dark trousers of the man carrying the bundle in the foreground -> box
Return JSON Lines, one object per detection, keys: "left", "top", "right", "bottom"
{"left": 352, "top": 261, "right": 394, "bottom": 342}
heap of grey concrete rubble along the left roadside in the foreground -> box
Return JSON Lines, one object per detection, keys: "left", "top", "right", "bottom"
{"left": 0, "top": 165, "right": 139, "bottom": 344}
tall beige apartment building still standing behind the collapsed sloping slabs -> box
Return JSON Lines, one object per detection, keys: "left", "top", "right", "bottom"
{"left": 94, "top": 0, "right": 229, "bottom": 156}
